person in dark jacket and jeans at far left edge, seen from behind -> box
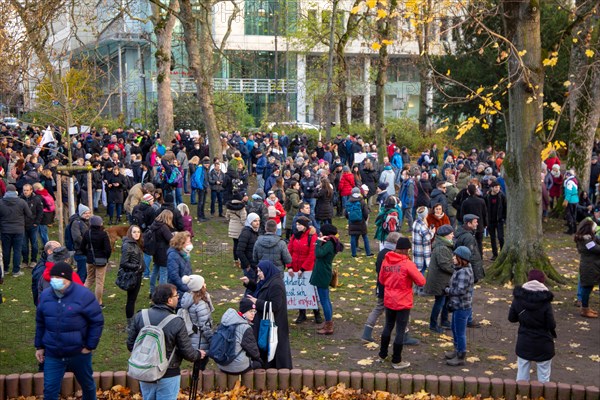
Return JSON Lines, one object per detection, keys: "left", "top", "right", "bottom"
{"left": 0, "top": 184, "right": 33, "bottom": 277}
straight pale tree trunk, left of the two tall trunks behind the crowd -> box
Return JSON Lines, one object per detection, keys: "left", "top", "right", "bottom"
{"left": 151, "top": 0, "right": 179, "bottom": 144}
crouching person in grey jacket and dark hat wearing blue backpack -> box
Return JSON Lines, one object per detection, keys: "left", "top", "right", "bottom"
{"left": 217, "top": 298, "right": 264, "bottom": 375}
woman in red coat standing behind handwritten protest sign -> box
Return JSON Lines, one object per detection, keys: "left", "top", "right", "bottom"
{"left": 287, "top": 217, "right": 323, "bottom": 324}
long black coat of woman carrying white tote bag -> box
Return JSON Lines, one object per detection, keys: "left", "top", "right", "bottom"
{"left": 248, "top": 274, "right": 292, "bottom": 369}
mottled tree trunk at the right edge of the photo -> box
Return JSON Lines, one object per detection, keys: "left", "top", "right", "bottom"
{"left": 567, "top": 0, "right": 600, "bottom": 190}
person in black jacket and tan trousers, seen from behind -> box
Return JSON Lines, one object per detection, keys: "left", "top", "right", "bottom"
{"left": 81, "top": 215, "right": 112, "bottom": 308}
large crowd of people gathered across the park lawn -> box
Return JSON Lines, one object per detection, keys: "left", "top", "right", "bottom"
{"left": 0, "top": 122, "right": 600, "bottom": 399}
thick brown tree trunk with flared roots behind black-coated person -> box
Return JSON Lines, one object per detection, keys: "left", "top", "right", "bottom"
{"left": 488, "top": 0, "right": 563, "bottom": 284}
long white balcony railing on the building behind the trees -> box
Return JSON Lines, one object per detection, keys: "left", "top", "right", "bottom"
{"left": 164, "top": 77, "right": 297, "bottom": 94}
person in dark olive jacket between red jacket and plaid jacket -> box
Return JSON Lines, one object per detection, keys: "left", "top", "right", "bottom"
{"left": 423, "top": 225, "right": 454, "bottom": 333}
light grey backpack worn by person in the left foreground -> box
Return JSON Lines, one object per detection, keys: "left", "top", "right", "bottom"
{"left": 127, "top": 309, "right": 177, "bottom": 382}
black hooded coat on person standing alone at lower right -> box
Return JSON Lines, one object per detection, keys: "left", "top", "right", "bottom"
{"left": 508, "top": 281, "right": 556, "bottom": 361}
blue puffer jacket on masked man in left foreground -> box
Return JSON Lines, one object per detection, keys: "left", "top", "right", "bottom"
{"left": 35, "top": 283, "right": 104, "bottom": 357}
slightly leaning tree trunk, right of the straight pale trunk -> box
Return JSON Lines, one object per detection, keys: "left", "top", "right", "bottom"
{"left": 180, "top": 0, "right": 223, "bottom": 159}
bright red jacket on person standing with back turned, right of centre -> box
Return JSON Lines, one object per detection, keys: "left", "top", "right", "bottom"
{"left": 379, "top": 251, "right": 425, "bottom": 310}
